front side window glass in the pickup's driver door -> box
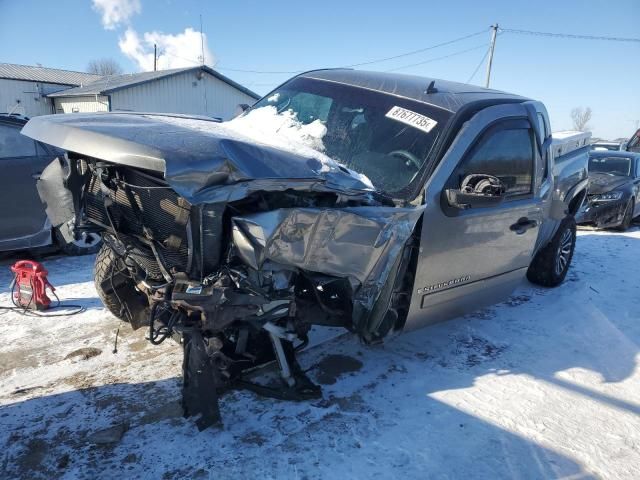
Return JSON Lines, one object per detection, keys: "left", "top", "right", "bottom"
{"left": 455, "top": 128, "right": 534, "bottom": 197}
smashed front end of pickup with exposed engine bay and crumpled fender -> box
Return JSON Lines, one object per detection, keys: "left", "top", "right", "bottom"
{"left": 39, "top": 153, "right": 421, "bottom": 429}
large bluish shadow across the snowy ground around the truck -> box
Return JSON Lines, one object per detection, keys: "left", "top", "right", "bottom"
{"left": 0, "top": 233, "right": 640, "bottom": 478}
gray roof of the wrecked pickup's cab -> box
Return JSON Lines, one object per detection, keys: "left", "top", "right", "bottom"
{"left": 300, "top": 68, "right": 529, "bottom": 112}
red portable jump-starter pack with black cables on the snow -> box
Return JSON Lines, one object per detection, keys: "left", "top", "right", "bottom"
{"left": 11, "top": 260, "right": 55, "bottom": 310}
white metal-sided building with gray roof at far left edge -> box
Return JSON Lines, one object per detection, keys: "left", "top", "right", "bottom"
{"left": 0, "top": 63, "right": 101, "bottom": 117}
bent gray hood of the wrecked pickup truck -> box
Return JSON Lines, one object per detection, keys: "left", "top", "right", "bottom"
{"left": 22, "top": 113, "right": 375, "bottom": 203}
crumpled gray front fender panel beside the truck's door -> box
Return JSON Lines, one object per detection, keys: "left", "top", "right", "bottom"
{"left": 232, "top": 207, "right": 423, "bottom": 316}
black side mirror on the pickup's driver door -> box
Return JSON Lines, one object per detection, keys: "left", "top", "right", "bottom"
{"left": 444, "top": 174, "right": 506, "bottom": 210}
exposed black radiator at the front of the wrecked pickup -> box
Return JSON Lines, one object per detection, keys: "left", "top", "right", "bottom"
{"left": 85, "top": 169, "right": 191, "bottom": 279}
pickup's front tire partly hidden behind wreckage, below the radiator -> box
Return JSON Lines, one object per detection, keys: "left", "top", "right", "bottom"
{"left": 93, "top": 243, "right": 149, "bottom": 329}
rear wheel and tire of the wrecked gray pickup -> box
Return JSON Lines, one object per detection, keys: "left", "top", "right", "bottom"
{"left": 527, "top": 216, "right": 576, "bottom": 287}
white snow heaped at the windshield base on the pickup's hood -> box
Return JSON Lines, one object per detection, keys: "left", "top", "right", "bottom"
{"left": 157, "top": 105, "right": 375, "bottom": 189}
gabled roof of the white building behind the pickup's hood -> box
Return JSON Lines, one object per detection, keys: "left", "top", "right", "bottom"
{"left": 47, "top": 66, "right": 260, "bottom": 99}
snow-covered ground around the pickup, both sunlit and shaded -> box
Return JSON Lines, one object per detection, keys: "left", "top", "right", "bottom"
{"left": 0, "top": 229, "right": 640, "bottom": 479}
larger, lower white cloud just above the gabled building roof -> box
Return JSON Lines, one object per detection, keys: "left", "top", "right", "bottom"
{"left": 118, "top": 27, "right": 215, "bottom": 71}
